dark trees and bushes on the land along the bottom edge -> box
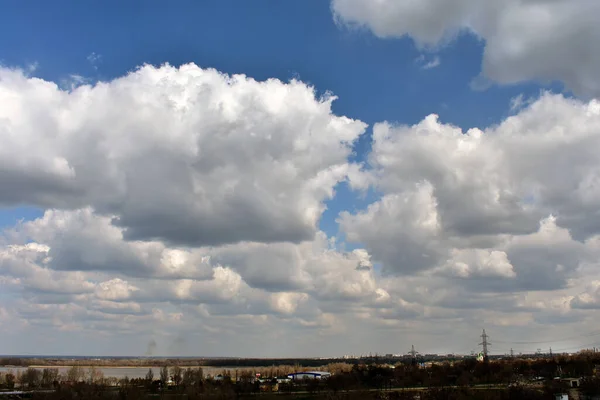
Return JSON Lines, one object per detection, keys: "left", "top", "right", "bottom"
{"left": 0, "top": 353, "right": 600, "bottom": 400}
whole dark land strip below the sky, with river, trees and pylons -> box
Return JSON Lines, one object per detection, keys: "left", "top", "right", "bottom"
{"left": 0, "top": 340, "right": 600, "bottom": 400}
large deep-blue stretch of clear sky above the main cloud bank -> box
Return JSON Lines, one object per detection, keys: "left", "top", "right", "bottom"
{"left": 0, "top": 0, "right": 539, "bottom": 127}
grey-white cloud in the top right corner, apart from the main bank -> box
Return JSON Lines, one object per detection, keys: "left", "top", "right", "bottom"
{"left": 331, "top": 0, "right": 600, "bottom": 96}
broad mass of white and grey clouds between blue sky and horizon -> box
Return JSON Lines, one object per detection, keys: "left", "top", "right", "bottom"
{"left": 0, "top": 65, "right": 600, "bottom": 356}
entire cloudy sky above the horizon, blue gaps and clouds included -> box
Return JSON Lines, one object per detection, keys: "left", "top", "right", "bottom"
{"left": 0, "top": 0, "right": 600, "bottom": 357}
